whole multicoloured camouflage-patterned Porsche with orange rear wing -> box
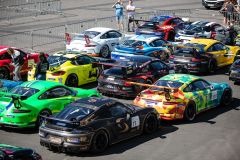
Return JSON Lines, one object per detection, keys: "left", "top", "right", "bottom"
{"left": 131, "top": 74, "right": 232, "bottom": 121}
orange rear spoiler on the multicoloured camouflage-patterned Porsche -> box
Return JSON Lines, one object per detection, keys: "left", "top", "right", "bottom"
{"left": 125, "top": 82, "right": 178, "bottom": 101}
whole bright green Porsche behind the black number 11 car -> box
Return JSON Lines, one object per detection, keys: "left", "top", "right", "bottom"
{"left": 0, "top": 81, "right": 101, "bottom": 128}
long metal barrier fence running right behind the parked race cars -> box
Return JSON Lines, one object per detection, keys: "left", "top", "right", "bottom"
{"left": 0, "top": 9, "right": 239, "bottom": 50}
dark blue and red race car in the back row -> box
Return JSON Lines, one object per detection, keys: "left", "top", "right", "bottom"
{"left": 132, "top": 15, "right": 189, "bottom": 42}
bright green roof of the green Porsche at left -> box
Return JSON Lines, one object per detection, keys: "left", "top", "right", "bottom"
{"left": 20, "top": 80, "right": 64, "bottom": 90}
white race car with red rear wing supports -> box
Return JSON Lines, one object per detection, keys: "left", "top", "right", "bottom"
{"left": 66, "top": 27, "right": 132, "bottom": 58}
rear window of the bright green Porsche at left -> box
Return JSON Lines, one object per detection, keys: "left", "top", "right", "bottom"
{"left": 5, "top": 87, "right": 39, "bottom": 98}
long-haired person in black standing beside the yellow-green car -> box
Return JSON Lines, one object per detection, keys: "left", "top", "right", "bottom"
{"left": 34, "top": 52, "right": 49, "bottom": 80}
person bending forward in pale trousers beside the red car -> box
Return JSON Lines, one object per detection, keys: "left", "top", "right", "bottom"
{"left": 7, "top": 48, "right": 25, "bottom": 81}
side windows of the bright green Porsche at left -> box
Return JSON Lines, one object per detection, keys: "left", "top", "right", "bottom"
{"left": 39, "top": 87, "right": 72, "bottom": 99}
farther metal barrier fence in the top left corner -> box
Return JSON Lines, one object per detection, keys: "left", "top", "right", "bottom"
{"left": 0, "top": 0, "right": 61, "bottom": 24}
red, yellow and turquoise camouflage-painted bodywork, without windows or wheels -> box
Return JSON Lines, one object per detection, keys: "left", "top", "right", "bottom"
{"left": 134, "top": 74, "right": 232, "bottom": 120}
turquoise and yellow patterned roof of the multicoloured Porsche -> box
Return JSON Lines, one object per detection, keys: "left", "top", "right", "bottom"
{"left": 160, "top": 74, "right": 202, "bottom": 83}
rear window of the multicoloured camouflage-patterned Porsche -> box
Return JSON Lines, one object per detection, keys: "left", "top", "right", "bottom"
{"left": 150, "top": 80, "right": 184, "bottom": 92}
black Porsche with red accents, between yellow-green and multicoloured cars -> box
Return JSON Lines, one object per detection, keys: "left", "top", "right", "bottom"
{"left": 97, "top": 56, "right": 189, "bottom": 97}
